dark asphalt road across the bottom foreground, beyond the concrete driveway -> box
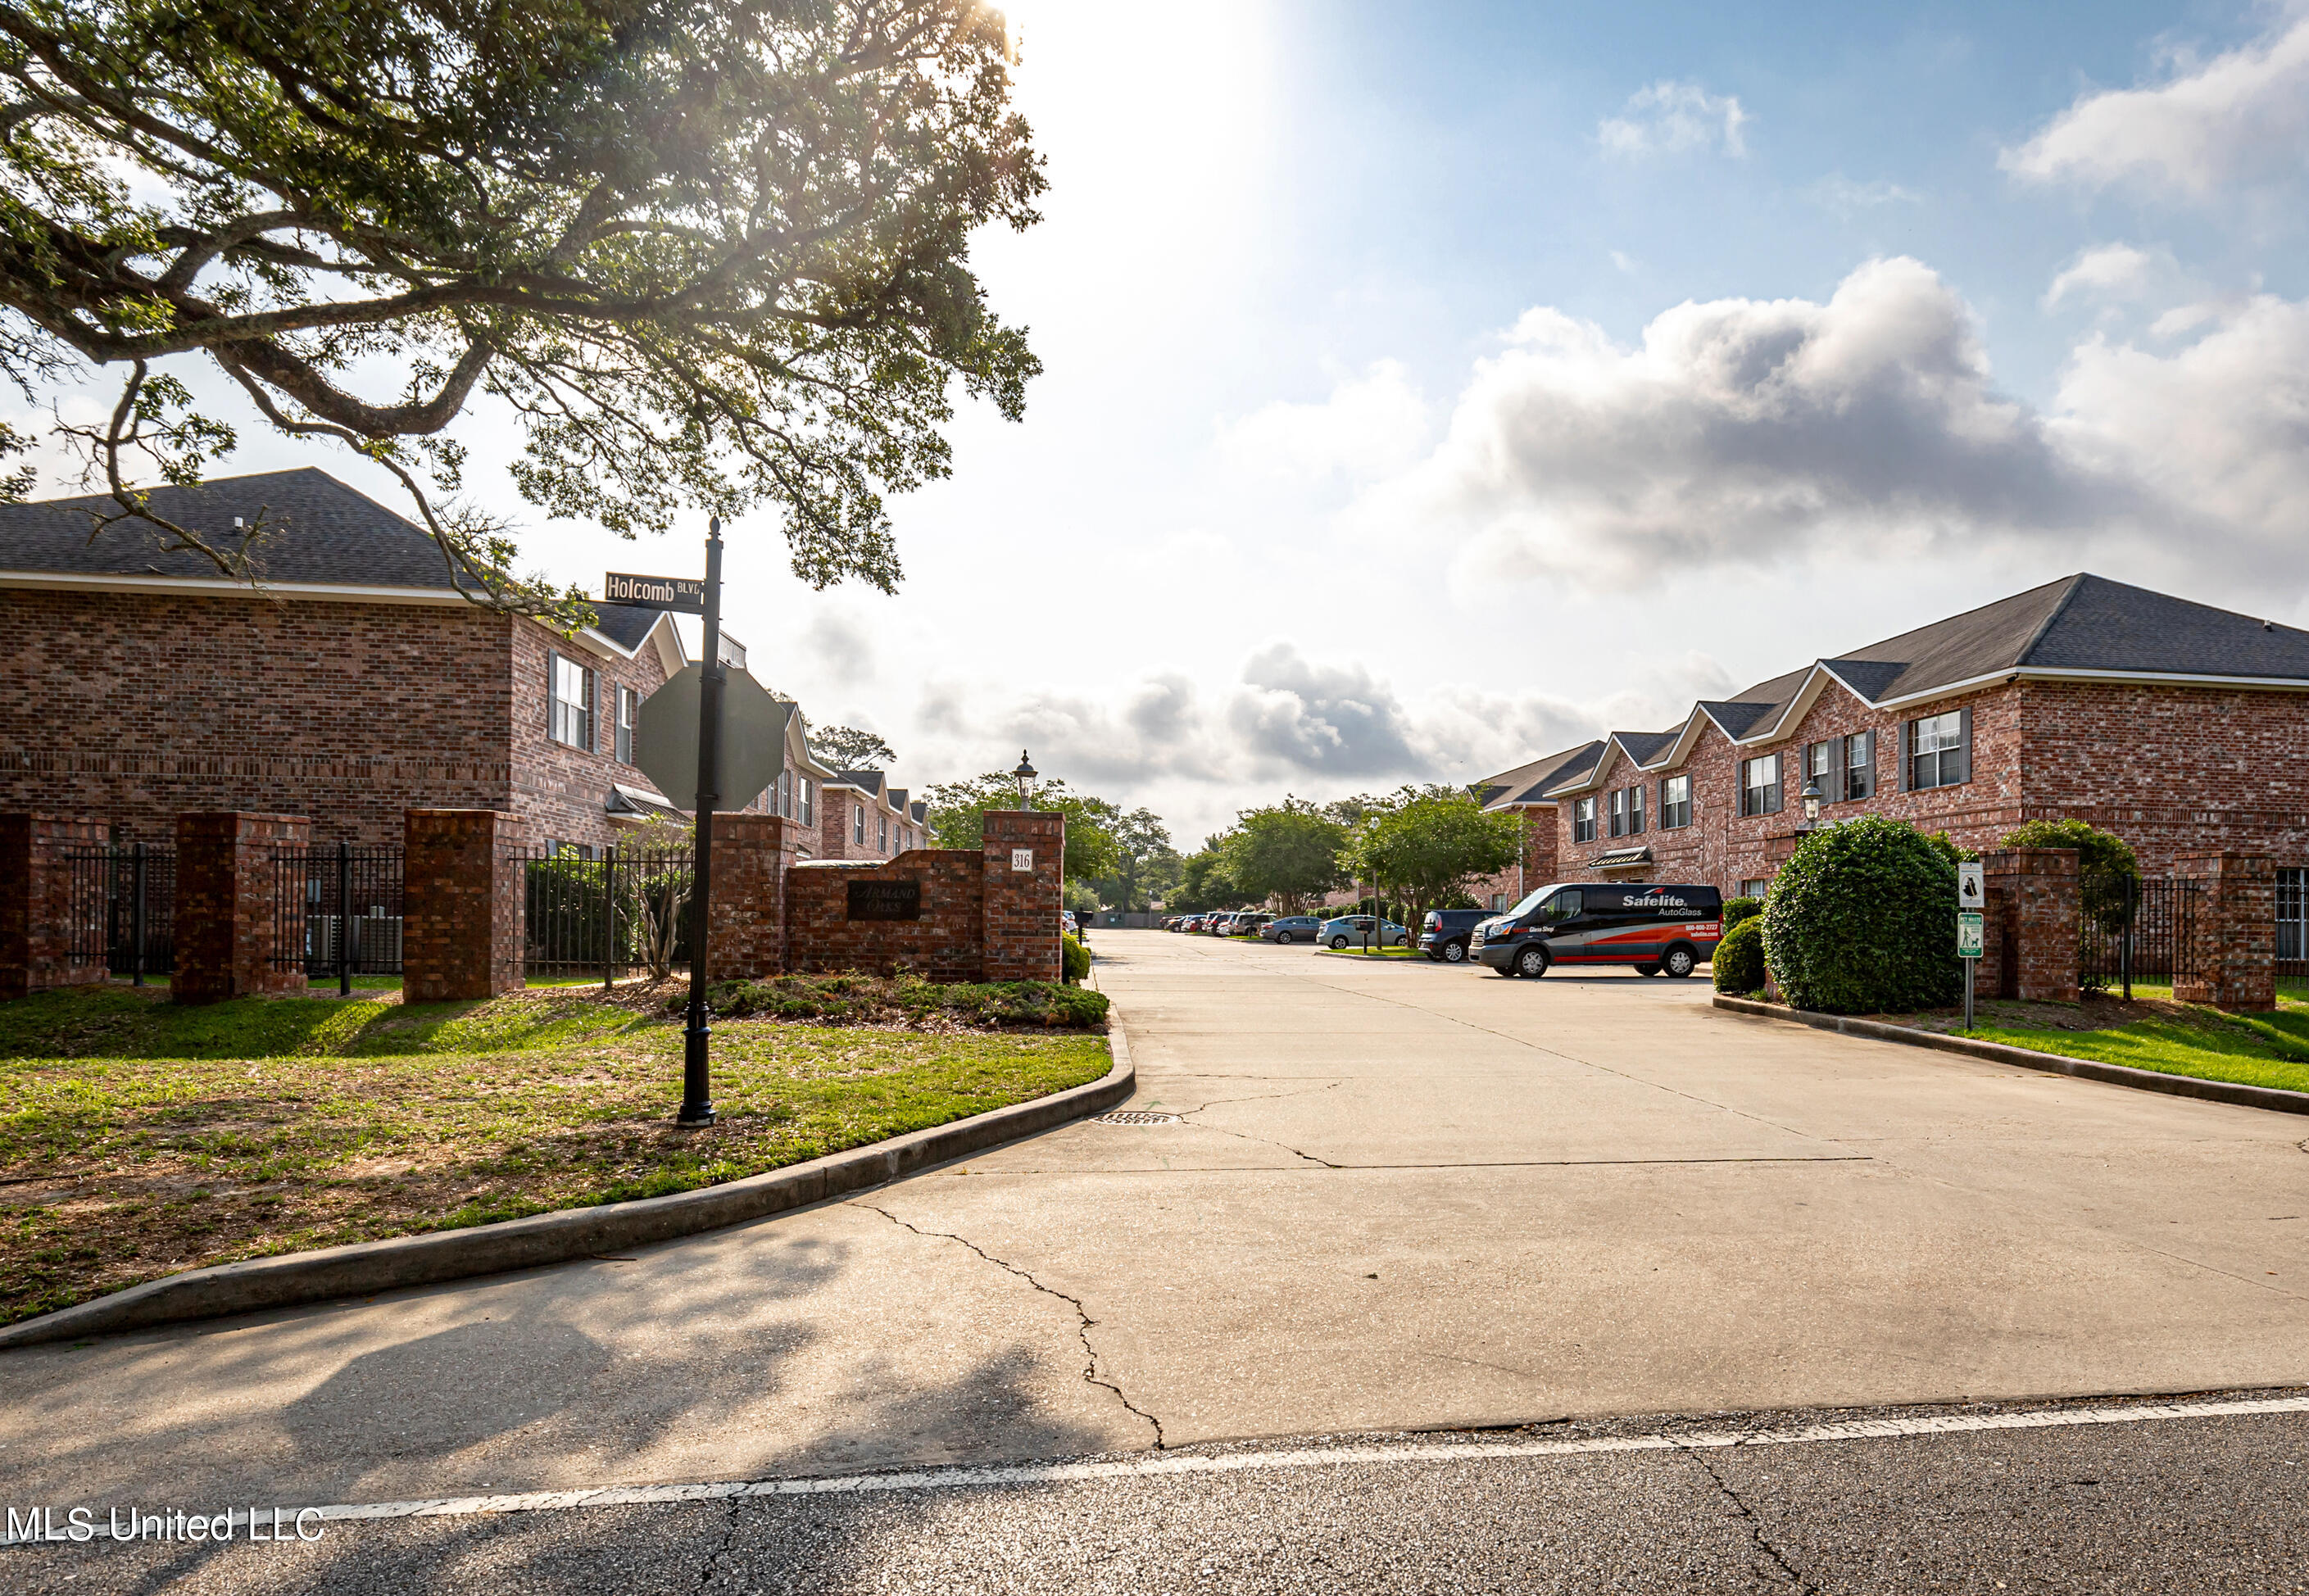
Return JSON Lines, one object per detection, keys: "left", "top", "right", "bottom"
{"left": 13, "top": 1393, "right": 2309, "bottom": 1596}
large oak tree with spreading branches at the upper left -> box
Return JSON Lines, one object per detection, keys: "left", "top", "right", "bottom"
{"left": 0, "top": 0, "right": 1044, "bottom": 623}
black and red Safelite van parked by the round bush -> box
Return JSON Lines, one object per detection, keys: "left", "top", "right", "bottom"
{"left": 1468, "top": 882, "right": 1725, "bottom": 979}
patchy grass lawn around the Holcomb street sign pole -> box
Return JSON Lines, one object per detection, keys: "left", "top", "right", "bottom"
{"left": 0, "top": 986, "right": 1110, "bottom": 1323}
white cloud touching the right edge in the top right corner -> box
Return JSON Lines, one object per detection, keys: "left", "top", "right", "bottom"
{"left": 1999, "top": 16, "right": 2309, "bottom": 198}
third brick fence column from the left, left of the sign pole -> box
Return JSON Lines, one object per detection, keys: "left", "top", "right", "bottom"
{"left": 401, "top": 809, "right": 524, "bottom": 1002}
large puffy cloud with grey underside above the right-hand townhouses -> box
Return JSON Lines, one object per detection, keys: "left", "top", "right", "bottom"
{"left": 1358, "top": 259, "right": 2122, "bottom": 584}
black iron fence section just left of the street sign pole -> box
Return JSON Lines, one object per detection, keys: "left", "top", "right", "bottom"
{"left": 515, "top": 846, "right": 695, "bottom": 986}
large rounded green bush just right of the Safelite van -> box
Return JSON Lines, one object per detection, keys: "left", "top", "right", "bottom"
{"left": 1762, "top": 815, "right": 1965, "bottom": 1014}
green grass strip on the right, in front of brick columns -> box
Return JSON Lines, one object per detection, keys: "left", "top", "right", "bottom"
{"left": 1965, "top": 982, "right": 2309, "bottom": 1092}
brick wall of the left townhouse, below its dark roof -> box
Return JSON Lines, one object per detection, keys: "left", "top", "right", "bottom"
{"left": 0, "top": 589, "right": 663, "bottom": 864}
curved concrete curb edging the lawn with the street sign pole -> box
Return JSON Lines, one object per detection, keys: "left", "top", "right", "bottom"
{"left": 0, "top": 1026, "right": 1136, "bottom": 1351}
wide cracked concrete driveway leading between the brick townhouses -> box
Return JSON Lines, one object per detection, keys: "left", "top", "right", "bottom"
{"left": 0, "top": 931, "right": 2309, "bottom": 1503}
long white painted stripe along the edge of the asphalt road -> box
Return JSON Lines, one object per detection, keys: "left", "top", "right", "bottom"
{"left": 13, "top": 1398, "right": 2309, "bottom": 1545}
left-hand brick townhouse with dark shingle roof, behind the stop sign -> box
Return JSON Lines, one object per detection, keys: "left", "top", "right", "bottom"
{"left": 0, "top": 469, "right": 921, "bottom": 857}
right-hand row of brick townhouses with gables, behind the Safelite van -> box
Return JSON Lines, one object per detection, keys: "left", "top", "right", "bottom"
{"left": 1476, "top": 575, "right": 2309, "bottom": 937}
